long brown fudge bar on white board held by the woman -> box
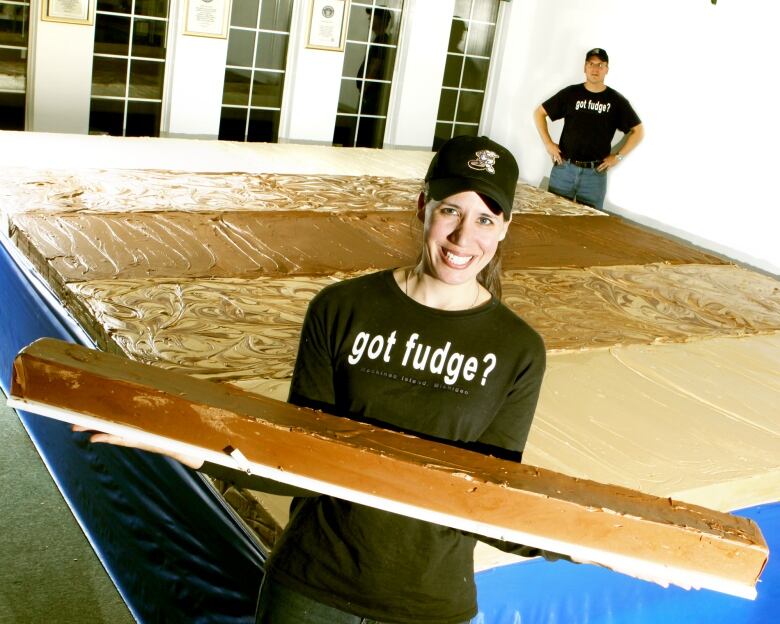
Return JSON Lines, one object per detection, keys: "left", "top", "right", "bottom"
{"left": 8, "top": 338, "right": 768, "bottom": 599}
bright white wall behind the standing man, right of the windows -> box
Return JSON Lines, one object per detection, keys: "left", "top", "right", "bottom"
{"left": 493, "top": 0, "right": 780, "bottom": 274}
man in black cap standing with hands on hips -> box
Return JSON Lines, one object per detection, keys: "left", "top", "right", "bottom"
{"left": 534, "top": 48, "right": 644, "bottom": 208}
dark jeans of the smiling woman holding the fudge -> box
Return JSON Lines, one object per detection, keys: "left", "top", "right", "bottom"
{"left": 255, "top": 577, "right": 468, "bottom": 624}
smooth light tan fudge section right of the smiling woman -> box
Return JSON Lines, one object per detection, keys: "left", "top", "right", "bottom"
{"left": 524, "top": 333, "right": 780, "bottom": 510}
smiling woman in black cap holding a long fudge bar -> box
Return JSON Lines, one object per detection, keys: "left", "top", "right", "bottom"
{"left": 77, "top": 137, "right": 545, "bottom": 624}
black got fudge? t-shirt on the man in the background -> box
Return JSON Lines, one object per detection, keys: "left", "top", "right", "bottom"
{"left": 542, "top": 84, "right": 641, "bottom": 161}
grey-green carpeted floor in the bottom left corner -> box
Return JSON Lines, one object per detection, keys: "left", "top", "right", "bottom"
{"left": 0, "top": 394, "right": 134, "bottom": 624}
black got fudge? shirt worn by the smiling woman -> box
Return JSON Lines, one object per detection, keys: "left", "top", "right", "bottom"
{"left": 207, "top": 271, "right": 545, "bottom": 624}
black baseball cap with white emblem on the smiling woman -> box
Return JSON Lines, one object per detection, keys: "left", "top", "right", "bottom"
{"left": 425, "top": 136, "right": 520, "bottom": 219}
